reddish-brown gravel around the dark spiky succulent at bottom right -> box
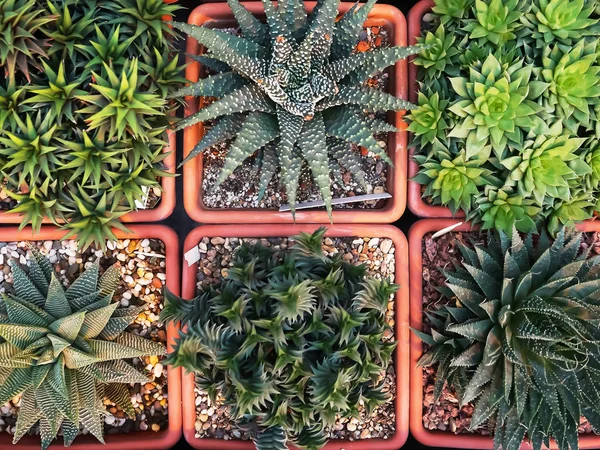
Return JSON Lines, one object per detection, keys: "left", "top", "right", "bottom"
{"left": 422, "top": 232, "right": 600, "bottom": 436}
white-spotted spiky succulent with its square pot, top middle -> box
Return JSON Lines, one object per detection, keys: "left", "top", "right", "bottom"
{"left": 174, "top": 0, "right": 417, "bottom": 223}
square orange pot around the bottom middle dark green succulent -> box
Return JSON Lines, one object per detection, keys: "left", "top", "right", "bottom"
{"left": 182, "top": 225, "right": 409, "bottom": 450}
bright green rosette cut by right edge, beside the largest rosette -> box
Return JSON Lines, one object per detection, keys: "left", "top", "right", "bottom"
{"left": 541, "top": 40, "right": 600, "bottom": 134}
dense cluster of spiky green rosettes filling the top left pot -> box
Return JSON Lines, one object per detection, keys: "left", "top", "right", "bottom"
{"left": 0, "top": 0, "right": 185, "bottom": 247}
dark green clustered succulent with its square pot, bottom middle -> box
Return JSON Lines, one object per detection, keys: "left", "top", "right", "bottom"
{"left": 170, "top": 225, "right": 408, "bottom": 449}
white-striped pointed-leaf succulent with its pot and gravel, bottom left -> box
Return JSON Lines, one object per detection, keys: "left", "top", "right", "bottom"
{"left": 0, "top": 225, "right": 181, "bottom": 450}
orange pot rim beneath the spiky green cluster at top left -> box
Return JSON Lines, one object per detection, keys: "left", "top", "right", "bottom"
{"left": 0, "top": 133, "right": 176, "bottom": 224}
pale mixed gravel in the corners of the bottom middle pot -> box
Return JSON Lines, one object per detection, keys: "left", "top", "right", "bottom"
{"left": 195, "top": 237, "right": 396, "bottom": 441}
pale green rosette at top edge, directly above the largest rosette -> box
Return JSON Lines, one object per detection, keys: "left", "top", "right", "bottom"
{"left": 463, "top": 0, "right": 523, "bottom": 46}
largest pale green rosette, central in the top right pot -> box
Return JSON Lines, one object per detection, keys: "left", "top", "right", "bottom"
{"left": 448, "top": 54, "right": 548, "bottom": 159}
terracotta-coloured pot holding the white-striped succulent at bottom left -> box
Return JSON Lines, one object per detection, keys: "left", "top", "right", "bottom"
{"left": 0, "top": 225, "right": 181, "bottom": 450}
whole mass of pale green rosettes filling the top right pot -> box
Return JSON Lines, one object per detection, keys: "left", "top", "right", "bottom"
{"left": 409, "top": 0, "right": 600, "bottom": 234}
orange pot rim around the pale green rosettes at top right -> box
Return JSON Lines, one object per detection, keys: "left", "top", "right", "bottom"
{"left": 408, "top": 0, "right": 465, "bottom": 217}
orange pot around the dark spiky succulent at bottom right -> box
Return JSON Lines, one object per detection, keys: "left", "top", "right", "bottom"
{"left": 408, "top": 219, "right": 600, "bottom": 450}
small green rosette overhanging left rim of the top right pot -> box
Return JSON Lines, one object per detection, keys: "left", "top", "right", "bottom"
{"left": 408, "top": 92, "right": 448, "bottom": 146}
